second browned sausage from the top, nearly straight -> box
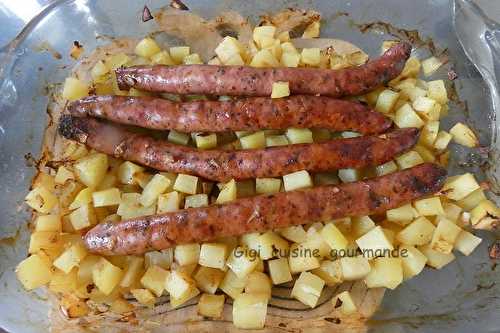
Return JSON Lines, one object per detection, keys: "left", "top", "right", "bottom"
{"left": 67, "top": 95, "right": 391, "bottom": 134}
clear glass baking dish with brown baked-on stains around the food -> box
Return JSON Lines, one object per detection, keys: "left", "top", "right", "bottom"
{"left": 0, "top": 0, "right": 500, "bottom": 332}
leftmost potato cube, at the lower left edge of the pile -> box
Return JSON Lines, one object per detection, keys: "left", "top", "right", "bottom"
{"left": 16, "top": 254, "right": 53, "bottom": 290}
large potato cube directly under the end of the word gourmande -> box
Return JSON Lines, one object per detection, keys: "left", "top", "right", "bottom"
{"left": 365, "top": 257, "right": 403, "bottom": 289}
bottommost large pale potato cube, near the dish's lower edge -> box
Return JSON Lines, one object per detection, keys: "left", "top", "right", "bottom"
{"left": 233, "top": 293, "right": 268, "bottom": 329}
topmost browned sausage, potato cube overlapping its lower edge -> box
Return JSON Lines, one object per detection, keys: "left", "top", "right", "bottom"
{"left": 116, "top": 43, "right": 411, "bottom": 97}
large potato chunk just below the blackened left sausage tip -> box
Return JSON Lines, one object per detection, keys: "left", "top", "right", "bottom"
{"left": 74, "top": 153, "right": 108, "bottom": 188}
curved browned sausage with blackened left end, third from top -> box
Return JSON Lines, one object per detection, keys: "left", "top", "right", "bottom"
{"left": 59, "top": 115, "right": 419, "bottom": 181}
